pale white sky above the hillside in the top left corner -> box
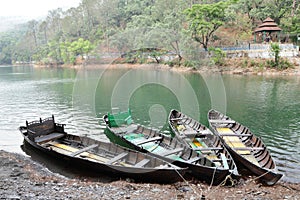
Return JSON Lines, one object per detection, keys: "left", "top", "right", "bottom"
{"left": 0, "top": 0, "right": 81, "bottom": 18}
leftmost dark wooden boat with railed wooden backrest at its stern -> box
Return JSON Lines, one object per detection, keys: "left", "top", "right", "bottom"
{"left": 19, "top": 116, "right": 186, "bottom": 183}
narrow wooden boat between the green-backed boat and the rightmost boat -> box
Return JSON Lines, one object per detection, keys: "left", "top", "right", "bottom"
{"left": 168, "top": 110, "right": 238, "bottom": 177}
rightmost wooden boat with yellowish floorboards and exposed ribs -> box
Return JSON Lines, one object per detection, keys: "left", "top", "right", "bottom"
{"left": 208, "top": 110, "right": 282, "bottom": 185}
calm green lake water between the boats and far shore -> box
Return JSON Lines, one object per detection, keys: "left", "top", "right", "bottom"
{"left": 0, "top": 66, "right": 300, "bottom": 182}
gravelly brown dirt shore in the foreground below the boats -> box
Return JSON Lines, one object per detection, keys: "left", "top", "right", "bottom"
{"left": 0, "top": 151, "right": 300, "bottom": 200}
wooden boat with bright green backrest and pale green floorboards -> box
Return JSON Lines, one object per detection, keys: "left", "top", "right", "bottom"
{"left": 103, "top": 111, "right": 234, "bottom": 185}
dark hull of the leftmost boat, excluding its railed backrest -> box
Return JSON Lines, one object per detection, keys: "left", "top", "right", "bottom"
{"left": 20, "top": 117, "right": 187, "bottom": 183}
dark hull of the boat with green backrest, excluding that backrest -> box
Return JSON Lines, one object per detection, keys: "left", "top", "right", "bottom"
{"left": 103, "top": 112, "right": 231, "bottom": 185}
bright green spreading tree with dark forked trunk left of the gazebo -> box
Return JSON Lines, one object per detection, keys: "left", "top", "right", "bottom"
{"left": 184, "top": 1, "right": 229, "bottom": 50}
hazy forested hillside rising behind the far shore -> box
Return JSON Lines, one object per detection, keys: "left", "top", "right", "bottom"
{"left": 0, "top": 0, "right": 300, "bottom": 64}
